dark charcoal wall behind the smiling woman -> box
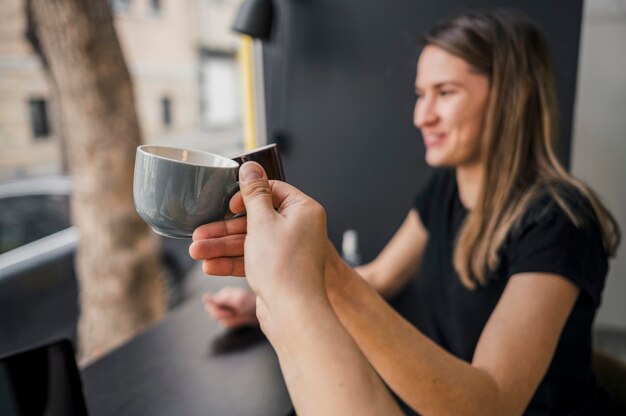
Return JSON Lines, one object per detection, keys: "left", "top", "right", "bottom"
{"left": 264, "top": 0, "right": 582, "bottom": 261}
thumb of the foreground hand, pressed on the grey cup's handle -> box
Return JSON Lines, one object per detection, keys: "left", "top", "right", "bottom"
{"left": 239, "top": 162, "right": 274, "bottom": 222}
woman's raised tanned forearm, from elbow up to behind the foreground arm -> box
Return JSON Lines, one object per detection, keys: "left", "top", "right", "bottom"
{"left": 326, "top": 242, "right": 506, "bottom": 415}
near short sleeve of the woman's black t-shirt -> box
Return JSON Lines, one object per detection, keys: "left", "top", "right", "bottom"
{"left": 506, "top": 197, "right": 608, "bottom": 306}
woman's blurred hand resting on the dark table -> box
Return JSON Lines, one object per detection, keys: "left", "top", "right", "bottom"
{"left": 202, "top": 286, "right": 259, "bottom": 328}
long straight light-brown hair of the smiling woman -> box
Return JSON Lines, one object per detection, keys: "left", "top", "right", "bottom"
{"left": 425, "top": 11, "right": 621, "bottom": 288}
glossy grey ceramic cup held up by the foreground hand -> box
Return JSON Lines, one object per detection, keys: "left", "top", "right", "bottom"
{"left": 133, "top": 145, "right": 239, "bottom": 238}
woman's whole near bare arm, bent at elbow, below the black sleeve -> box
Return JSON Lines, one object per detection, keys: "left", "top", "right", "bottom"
{"left": 326, "top": 244, "right": 578, "bottom": 415}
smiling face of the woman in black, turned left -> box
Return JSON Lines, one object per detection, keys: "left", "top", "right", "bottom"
{"left": 413, "top": 45, "right": 489, "bottom": 167}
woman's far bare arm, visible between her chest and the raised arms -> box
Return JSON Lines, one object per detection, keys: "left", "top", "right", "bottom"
{"left": 355, "top": 209, "right": 428, "bottom": 299}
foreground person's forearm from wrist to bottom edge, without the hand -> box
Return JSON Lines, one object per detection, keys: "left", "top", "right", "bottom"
{"left": 262, "top": 298, "right": 401, "bottom": 415}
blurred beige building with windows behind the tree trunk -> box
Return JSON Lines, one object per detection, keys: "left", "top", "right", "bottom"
{"left": 0, "top": 0, "right": 241, "bottom": 179}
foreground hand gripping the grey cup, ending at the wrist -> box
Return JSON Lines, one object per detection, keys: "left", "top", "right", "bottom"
{"left": 239, "top": 163, "right": 327, "bottom": 304}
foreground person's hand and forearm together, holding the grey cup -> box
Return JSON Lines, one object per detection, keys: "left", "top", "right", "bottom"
{"left": 234, "top": 163, "right": 400, "bottom": 415}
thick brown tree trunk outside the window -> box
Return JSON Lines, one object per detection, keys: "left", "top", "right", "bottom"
{"left": 28, "top": 0, "right": 165, "bottom": 364}
